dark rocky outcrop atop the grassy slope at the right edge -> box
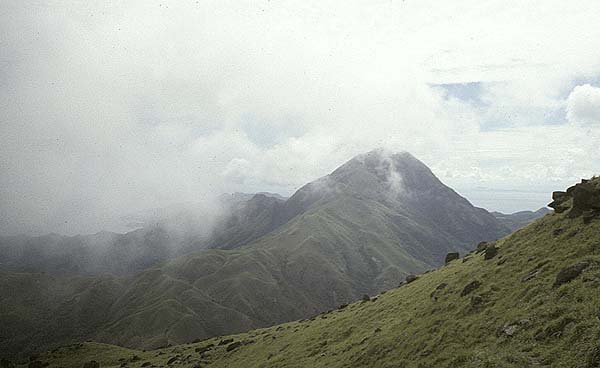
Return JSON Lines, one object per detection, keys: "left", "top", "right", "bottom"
{"left": 548, "top": 177, "right": 600, "bottom": 222}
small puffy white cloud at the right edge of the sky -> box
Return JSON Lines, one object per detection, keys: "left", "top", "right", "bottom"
{"left": 567, "top": 84, "right": 600, "bottom": 125}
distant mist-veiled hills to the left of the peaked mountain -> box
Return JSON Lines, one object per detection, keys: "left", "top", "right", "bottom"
{"left": 0, "top": 193, "right": 284, "bottom": 276}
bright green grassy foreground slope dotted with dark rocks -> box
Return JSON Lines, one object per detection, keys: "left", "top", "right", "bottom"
{"left": 17, "top": 179, "right": 600, "bottom": 368}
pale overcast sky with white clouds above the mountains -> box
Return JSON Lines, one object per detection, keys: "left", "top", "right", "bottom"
{"left": 0, "top": 0, "right": 600, "bottom": 234}
